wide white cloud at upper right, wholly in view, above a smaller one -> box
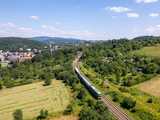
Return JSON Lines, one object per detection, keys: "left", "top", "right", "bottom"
{"left": 105, "top": 6, "right": 131, "bottom": 13}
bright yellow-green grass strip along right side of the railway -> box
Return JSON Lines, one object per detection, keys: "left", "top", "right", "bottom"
{"left": 81, "top": 65, "right": 160, "bottom": 120}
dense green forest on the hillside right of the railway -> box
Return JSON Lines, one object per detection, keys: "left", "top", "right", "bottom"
{"left": 83, "top": 37, "right": 160, "bottom": 86}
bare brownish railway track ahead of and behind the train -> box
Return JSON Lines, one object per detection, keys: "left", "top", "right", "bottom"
{"left": 73, "top": 55, "right": 133, "bottom": 120}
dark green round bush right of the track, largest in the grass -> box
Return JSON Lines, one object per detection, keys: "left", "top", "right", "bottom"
{"left": 120, "top": 97, "right": 136, "bottom": 109}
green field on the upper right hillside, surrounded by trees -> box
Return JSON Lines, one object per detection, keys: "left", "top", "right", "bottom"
{"left": 134, "top": 45, "right": 160, "bottom": 57}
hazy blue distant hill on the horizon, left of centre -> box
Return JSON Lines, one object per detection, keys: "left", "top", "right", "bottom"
{"left": 31, "top": 36, "right": 84, "bottom": 44}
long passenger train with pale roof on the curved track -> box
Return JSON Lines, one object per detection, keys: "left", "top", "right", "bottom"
{"left": 75, "top": 67, "right": 101, "bottom": 99}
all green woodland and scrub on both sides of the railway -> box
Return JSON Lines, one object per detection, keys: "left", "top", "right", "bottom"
{"left": 0, "top": 36, "right": 160, "bottom": 120}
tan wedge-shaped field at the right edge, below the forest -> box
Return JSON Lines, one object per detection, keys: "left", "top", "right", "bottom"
{"left": 138, "top": 76, "right": 160, "bottom": 97}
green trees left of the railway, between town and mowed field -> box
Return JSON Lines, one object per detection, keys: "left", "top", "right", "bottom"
{"left": 0, "top": 43, "right": 112, "bottom": 120}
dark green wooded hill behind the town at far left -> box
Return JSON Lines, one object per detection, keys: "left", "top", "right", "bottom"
{"left": 0, "top": 37, "right": 44, "bottom": 50}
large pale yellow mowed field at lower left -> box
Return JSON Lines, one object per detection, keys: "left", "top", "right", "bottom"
{"left": 0, "top": 80, "right": 71, "bottom": 120}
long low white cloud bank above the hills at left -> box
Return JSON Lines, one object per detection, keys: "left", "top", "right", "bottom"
{"left": 0, "top": 22, "right": 107, "bottom": 39}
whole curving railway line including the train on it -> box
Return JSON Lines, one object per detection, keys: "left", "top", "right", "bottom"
{"left": 73, "top": 53, "right": 133, "bottom": 120}
